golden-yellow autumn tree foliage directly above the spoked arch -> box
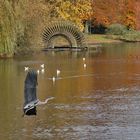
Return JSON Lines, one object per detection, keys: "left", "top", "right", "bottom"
{"left": 49, "top": 0, "right": 91, "bottom": 30}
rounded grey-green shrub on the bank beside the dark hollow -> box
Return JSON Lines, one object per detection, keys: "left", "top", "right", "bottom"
{"left": 106, "top": 24, "right": 127, "bottom": 35}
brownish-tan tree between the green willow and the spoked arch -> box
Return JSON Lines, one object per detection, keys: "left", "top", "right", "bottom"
{"left": 25, "top": 0, "right": 53, "bottom": 47}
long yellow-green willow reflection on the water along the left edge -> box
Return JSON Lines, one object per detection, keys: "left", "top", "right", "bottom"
{"left": 0, "top": 59, "right": 20, "bottom": 139}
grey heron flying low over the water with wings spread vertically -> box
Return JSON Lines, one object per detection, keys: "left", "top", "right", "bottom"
{"left": 23, "top": 70, "right": 54, "bottom": 116}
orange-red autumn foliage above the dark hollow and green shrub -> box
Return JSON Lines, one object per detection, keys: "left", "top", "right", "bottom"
{"left": 92, "top": 0, "right": 138, "bottom": 29}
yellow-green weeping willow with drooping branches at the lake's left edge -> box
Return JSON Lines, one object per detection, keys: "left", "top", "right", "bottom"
{"left": 0, "top": 0, "right": 26, "bottom": 57}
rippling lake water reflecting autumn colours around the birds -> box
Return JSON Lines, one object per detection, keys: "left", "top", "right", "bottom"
{"left": 0, "top": 44, "right": 140, "bottom": 140}
